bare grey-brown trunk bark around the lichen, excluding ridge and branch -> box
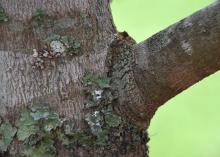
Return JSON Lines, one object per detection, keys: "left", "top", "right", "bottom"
{"left": 0, "top": 0, "right": 146, "bottom": 157}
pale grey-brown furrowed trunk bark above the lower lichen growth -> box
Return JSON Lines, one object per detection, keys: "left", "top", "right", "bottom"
{"left": 0, "top": 0, "right": 115, "bottom": 125}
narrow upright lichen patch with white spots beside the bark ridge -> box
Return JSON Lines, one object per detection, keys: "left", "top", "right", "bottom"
{"left": 82, "top": 73, "right": 122, "bottom": 134}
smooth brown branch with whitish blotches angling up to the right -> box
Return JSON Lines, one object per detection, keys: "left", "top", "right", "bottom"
{"left": 134, "top": 1, "right": 220, "bottom": 127}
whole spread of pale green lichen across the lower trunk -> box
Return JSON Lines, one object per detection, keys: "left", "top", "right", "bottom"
{"left": 0, "top": 72, "right": 141, "bottom": 157}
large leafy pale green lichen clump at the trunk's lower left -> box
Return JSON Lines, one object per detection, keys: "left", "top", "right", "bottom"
{"left": 9, "top": 104, "right": 64, "bottom": 157}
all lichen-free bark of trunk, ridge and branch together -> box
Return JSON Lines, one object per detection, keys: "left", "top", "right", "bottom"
{"left": 0, "top": 0, "right": 220, "bottom": 157}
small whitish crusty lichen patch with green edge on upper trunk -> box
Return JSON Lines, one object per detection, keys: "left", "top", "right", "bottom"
{"left": 31, "top": 34, "right": 81, "bottom": 69}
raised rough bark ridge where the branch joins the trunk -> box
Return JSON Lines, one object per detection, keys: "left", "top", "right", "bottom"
{"left": 107, "top": 32, "right": 150, "bottom": 130}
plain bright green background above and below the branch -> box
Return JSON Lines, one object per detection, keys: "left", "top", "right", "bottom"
{"left": 111, "top": 0, "right": 220, "bottom": 157}
